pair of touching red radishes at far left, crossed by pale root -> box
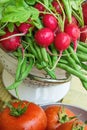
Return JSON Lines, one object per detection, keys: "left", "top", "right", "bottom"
{"left": 0, "top": 20, "right": 32, "bottom": 52}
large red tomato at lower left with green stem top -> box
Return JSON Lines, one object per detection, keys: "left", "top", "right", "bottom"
{"left": 0, "top": 101, "right": 47, "bottom": 130}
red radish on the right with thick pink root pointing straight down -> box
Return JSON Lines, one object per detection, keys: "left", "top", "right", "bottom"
{"left": 65, "top": 23, "right": 80, "bottom": 52}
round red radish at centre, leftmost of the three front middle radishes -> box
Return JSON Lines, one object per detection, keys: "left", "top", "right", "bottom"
{"left": 35, "top": 28, "right": 54, "bottom": 47}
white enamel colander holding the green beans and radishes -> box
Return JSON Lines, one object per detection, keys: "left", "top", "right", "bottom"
{"left": 0, "top": 49, "right": 71, "bottom": 104}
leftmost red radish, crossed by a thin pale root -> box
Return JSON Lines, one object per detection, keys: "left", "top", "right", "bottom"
{"left": 0, "top": 31, "right": 21, "bottom": 52}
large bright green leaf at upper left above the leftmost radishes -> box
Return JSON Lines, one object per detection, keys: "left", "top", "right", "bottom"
{"left": 1, "top": 5, "right": 39, "bottom": 23}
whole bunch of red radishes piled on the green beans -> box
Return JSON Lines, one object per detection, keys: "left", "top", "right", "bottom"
{"left": 0, "top": 0, "right": 87, "bottom": 57}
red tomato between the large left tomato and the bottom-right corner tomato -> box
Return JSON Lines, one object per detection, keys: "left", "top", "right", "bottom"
{"left": 45, "top": 105, "right": 75, "bottom": 130}
